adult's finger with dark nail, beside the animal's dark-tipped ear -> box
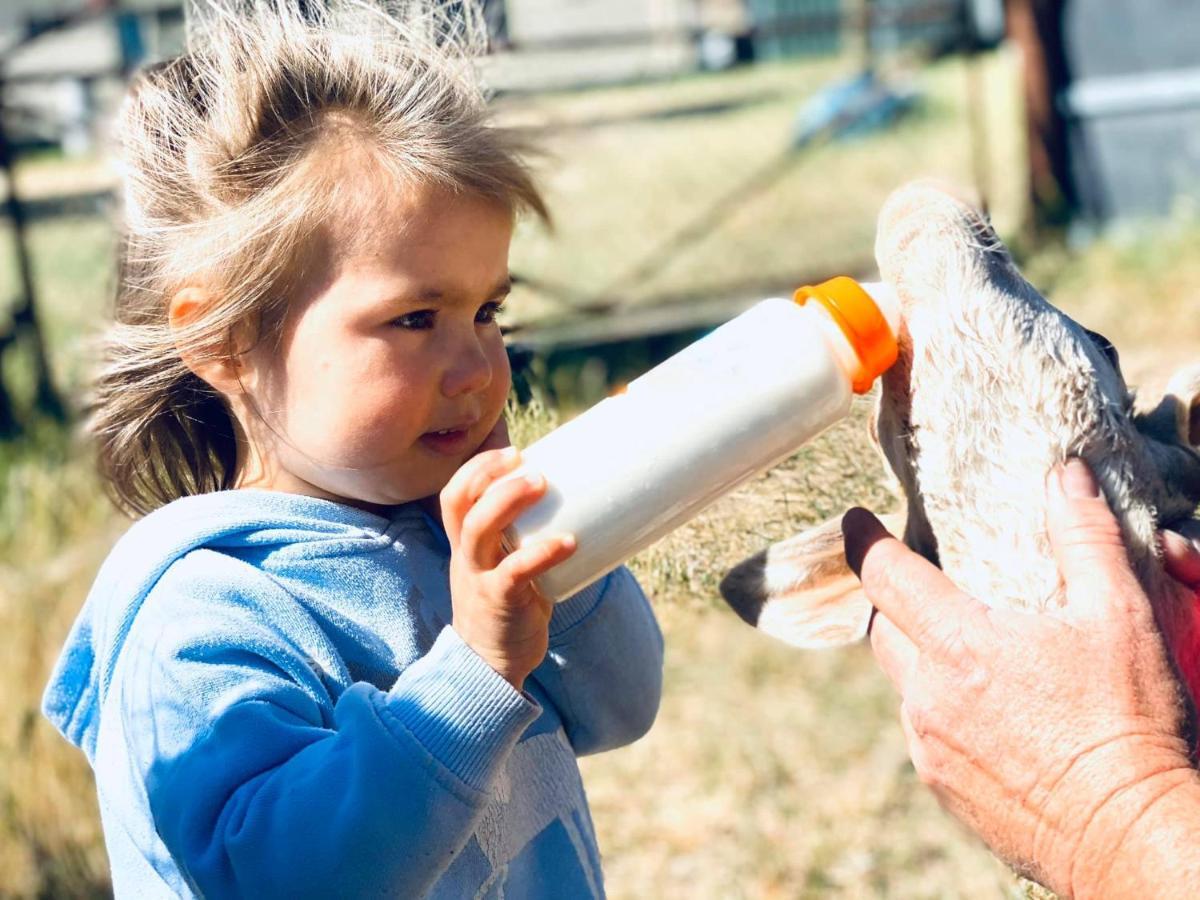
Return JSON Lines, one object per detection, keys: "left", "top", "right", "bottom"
{"left": 841, "top": 509, "right": 986, "bottom": 650}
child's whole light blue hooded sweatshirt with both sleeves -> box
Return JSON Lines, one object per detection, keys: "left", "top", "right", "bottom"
{"left": 43, "top": 491, "right": 662, "bottom": 899}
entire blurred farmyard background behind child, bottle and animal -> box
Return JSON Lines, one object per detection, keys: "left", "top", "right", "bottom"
{"left": 0, "top": 0, "right": 1200, "bottom": 898}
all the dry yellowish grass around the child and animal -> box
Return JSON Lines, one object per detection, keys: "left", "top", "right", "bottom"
{"left": 0, "top": 45, "right": 1200, "bottom": 898}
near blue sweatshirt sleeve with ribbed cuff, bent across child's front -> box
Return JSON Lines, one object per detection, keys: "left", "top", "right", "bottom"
{"left": 117, "top": 560, "right": 540, "bottom": 898}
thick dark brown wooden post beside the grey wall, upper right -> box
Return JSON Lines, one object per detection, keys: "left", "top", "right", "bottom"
{"left": 1006, "top": 0, "right": 1078, "bottom": 229}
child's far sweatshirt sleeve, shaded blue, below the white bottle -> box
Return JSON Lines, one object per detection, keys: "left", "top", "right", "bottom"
{"left": 533, "top": 566, "right": 662, "bottom": 756}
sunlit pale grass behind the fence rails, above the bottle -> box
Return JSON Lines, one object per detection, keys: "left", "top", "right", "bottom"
{"left": 496, "top": 45, "right": 1024, "bottom": 323}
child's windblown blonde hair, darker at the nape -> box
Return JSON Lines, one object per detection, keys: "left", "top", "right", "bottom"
{"left": 89, "top": 0, "right": 548, "bottom": 514}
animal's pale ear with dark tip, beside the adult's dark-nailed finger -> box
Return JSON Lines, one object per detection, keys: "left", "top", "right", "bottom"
{"left": 721, "top": 515, "right": 904, "bottom": 649}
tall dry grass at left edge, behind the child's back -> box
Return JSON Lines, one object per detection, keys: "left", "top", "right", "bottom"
{"left": 0, "top": 437, "right": 120, "bottom": 898}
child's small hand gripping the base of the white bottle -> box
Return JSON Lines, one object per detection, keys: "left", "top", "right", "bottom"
{"left": 440, "top": 448, "right": 575, "bottom": 690}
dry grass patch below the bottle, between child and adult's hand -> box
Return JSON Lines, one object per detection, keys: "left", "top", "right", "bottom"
{"left": 583, "top": 401, "right": 1018, "bottom": 898}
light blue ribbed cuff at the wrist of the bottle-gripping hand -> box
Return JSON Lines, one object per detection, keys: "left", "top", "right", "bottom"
{"left": 389, "top": 626, "right": 541, "bottom": 791}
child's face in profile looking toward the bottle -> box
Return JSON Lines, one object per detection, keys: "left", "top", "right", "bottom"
{"left": 239, "top": 181, "right": 512, "bottom": 506}
